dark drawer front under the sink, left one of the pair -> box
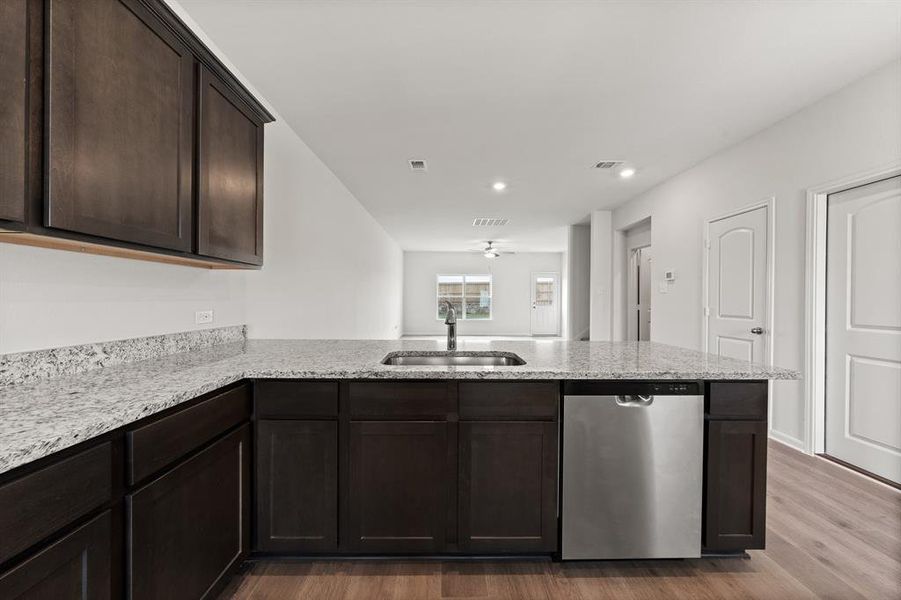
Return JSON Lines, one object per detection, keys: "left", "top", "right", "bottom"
{"left": 348, "top": 382, "right": 456, "bottom": 421}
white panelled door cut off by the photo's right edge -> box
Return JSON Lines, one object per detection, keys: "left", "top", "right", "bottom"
{"left": 826, "top": 177, "right": 901, "bottom": 483}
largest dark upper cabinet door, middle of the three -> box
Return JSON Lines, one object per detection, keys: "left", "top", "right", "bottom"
{"left": 45, "top": 0, "right": 194, "bottom": 250}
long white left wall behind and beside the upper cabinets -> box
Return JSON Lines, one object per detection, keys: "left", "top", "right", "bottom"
{"left": 0, "top": 1, "right": 403, "bottom": 353}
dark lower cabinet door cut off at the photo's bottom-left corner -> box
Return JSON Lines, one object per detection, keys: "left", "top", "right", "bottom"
{"left": 0, "top": 511, "right": 111, "bottom": 600}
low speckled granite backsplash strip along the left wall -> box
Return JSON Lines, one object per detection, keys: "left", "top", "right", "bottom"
{"left": 0, "top": 325, "right": 246, "bottom": 385}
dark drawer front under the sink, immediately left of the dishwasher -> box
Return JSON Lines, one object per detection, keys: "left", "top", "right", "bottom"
{"left": 460, "top": 381, "right": 560, "bottom": 421}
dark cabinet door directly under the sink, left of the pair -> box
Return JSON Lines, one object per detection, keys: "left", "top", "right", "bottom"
{"left": 350, "top": 421, "right": 453, "bottom": 554}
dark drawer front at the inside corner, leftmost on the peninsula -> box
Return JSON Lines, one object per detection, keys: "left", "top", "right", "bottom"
{"left": 254, "top": 380, "right": 338, "bottom": 419}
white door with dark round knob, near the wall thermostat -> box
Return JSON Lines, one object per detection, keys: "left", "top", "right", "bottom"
{"left": 707, "top": 206, "right": 769, "bottom": 362}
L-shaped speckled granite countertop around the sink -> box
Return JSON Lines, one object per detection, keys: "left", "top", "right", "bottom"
{"left": 0, "top": 340, "right": 799, "bottom": 473}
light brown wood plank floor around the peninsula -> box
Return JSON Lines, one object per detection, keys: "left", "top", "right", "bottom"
{"left": 220, "top": 442, "right": 901, "bottom": 600}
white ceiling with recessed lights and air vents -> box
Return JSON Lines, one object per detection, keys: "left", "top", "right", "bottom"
{"left": 179, "top": 0, "right": 901, "bottom": 251}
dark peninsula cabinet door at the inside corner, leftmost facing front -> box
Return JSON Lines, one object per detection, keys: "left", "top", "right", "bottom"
{"left": 256, "top": 420, "right": 338, "bottom": 552}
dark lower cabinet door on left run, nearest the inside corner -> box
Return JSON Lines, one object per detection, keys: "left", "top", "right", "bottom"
{"left": 126, "top": 425, "right": 250, "bottom": 600}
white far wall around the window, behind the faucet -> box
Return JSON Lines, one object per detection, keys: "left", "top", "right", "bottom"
{"left": 404, "top": 252, "right": 563, "bottom": 335}
